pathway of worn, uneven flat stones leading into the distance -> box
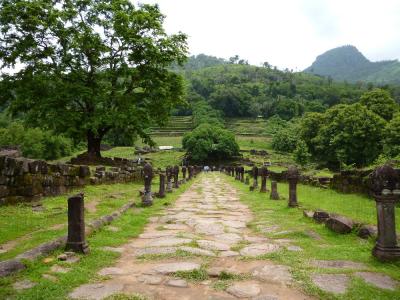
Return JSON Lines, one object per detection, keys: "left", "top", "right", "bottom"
{"left": 70, "top": 173, "right": 311, "bottom": 300}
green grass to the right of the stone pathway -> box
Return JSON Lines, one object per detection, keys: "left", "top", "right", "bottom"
{"left": 223, "top": 176, "right": 400, "bottom": 300}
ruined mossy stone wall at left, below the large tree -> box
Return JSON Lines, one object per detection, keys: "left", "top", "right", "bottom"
{"left": 0, "top": 156, "right": 142, "bottom": 205}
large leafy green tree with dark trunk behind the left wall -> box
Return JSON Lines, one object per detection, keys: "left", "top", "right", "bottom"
{"left": 0, "top": 0, "right": 187, "bottom": 157}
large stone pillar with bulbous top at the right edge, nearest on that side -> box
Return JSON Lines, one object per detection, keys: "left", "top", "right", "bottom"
{"left": 370, "top": 165, "right": 400, "bottom": 261}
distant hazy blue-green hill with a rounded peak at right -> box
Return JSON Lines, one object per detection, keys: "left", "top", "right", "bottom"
{"left": 304, "top": 45, "right": 400, "bottom": 84}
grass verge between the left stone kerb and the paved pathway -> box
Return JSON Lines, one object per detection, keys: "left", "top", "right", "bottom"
{"left": 0, "top": 177, "right": 194, "bottom": 300}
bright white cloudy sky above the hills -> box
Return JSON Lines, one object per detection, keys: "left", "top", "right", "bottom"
{"left": 136, "top": 0, "right": 400, "bottom": 70}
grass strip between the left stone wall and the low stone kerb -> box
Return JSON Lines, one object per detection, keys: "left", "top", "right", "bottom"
{"left": 0, "top": 183, "right": 145, "bottom": 260}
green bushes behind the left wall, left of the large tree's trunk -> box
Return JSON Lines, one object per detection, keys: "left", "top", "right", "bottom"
{"left": 0, "top": 122, "right": 73, "bottom": 160}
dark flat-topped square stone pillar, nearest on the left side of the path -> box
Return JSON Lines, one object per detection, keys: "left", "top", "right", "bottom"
{"left": 65, "top": 193, "right": 89, "bottom": 254}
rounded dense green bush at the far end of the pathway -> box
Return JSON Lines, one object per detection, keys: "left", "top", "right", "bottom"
{"left": 182, "top": 124, "right": 239, "bottom": 162}
